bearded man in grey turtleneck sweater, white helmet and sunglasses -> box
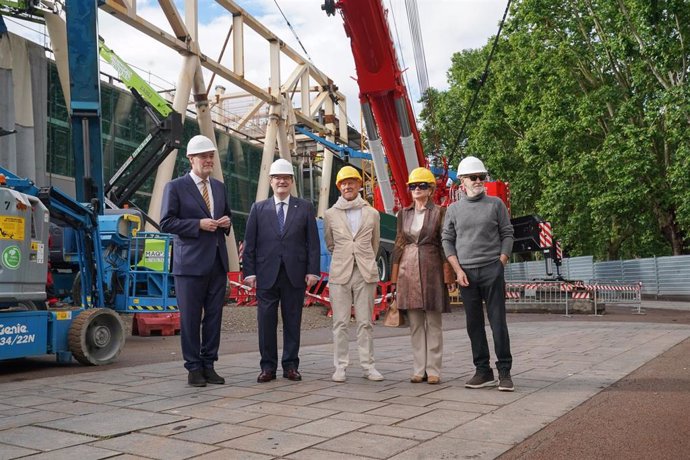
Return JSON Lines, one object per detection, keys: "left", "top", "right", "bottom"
{"left": 443, "top": 156, "right": 514, "bottom": 391}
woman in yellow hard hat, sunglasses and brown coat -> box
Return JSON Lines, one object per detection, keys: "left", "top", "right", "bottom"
{"left": 391, "top": 168, "right": 455, "bottom": 384}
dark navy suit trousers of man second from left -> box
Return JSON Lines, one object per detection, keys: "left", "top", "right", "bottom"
{"left": 256, "top": 264, "right": 304, "bottom": 372}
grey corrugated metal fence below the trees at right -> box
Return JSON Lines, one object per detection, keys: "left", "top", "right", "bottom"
{"left": 506, "top": 255, "right": 690, "bottom": 298}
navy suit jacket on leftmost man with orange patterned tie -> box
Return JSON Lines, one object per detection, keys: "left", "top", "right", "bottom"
{"left": 161, "top": 174, "right": 231, "bottom": 276}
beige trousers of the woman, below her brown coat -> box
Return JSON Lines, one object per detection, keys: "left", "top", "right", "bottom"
{"left": 406, "top": 309, "right": 443, "bottom": 377}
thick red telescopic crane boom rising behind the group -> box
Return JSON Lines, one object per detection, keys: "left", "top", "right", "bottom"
{"left": 321, "top": 0, "right": 425, "bottom": 213}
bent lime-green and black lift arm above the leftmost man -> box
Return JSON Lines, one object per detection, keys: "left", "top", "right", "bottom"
{"left": 98, "top": 39, "right": 182, "bottom": 207}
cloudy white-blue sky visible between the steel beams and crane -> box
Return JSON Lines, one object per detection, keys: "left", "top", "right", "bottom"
{"left": 6, "top": 0, "right": 506, "bottom": 128}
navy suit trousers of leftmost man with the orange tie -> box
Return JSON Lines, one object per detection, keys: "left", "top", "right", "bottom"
{"left": 175, "top": 255, "right": 227, "bottom": 371}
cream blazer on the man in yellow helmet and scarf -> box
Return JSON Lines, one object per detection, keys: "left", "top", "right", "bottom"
{"left": 324, "top": 206, "right": 381, "bottom": 284}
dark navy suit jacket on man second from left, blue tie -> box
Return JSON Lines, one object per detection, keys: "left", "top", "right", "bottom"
{"left": 242, "top": 196, "right": 321, "bottom": 289}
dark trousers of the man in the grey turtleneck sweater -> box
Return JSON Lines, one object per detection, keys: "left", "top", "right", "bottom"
{"left": 460, "top": 260, "right": 513, "bottom": 373}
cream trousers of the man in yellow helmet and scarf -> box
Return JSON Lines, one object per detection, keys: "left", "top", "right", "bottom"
{"left": 329, "top": 268, "right": 376, "bottom": 370}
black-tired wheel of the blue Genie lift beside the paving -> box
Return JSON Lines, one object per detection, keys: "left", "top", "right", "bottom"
{"left": 68, "top": 308, "right": 125, "bottom": 366}
